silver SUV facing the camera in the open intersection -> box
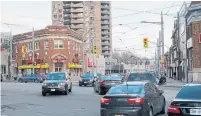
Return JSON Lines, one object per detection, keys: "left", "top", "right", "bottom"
{"left": 42, "top": 72, "right": 72, "bottom": 96}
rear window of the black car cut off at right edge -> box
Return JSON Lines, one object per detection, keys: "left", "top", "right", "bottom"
{"left": 176, "top": 85, "right": 201, "bottom": 100}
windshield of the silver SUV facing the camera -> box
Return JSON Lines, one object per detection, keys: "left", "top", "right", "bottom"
{"left": 47, "top": 73, "right": 66, "bottom": 80}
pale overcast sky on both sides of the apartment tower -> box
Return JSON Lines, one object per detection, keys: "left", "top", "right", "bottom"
{"left": 0, "top": 1, "right": 186, "bottom": 58}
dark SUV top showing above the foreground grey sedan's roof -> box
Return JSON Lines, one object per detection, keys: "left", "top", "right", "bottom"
{"left": 127, "top": 73, "right": 158, "bottom": 84}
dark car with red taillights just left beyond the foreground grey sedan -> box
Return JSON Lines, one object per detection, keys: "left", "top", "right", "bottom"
{"left": 93, "top": 75, "right": 122, "bottom": 95}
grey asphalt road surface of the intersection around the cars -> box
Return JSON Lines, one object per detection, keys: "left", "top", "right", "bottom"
{"left": 1, "top": 83, "right": 181, "bottom": 116}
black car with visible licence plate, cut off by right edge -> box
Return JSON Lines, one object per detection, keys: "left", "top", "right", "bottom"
{"left": 168, "top": 84, "right": 201, "bottom": 116}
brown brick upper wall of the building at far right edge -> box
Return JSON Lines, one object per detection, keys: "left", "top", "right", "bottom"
{"left": 192, "top": 21, "right": 201, "bottom": 68}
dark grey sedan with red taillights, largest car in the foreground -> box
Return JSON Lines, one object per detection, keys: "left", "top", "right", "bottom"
{"left": 100, "top": 81, "right": 166, "bottom": 116}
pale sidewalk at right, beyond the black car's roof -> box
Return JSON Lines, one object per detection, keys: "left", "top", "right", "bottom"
{"left": 163, "top": 77, "right": 187, "bottom": 88}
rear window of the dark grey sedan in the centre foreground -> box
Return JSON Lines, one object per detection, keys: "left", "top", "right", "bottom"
{"left": 107, "top": 85, "right": 143, "bottom": 94}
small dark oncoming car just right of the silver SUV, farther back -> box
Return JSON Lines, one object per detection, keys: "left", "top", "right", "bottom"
{"left": 79, "top": 73, "right": 94, "bottom": 86}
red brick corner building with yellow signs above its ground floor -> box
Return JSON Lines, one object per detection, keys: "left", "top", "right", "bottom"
{"left": 13, "top": 25, "right": 83, "bottom": 74}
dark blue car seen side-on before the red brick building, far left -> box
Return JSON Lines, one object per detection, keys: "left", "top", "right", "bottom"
{"left": 18, "top": 74, "right": 42, "bottom": 83}
